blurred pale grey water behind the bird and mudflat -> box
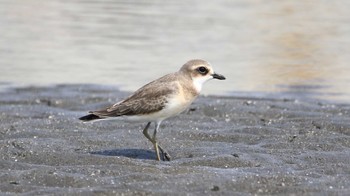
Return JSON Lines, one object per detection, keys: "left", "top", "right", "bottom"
{"left": 0, "top": 0, "right": 350, "bottom": 102}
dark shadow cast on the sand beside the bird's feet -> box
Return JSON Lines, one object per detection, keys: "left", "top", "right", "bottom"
{"left": 90, "top": 148, "right": 156, "bottom": 160}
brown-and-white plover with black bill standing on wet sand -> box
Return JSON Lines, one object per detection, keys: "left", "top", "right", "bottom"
{"left": 79, "top": 59, "right": 225, "bottom": 161}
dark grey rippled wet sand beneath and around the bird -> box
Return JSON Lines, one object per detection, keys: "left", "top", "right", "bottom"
{"left": 0, "top": 85, "right": 350, "bottom": 195}
